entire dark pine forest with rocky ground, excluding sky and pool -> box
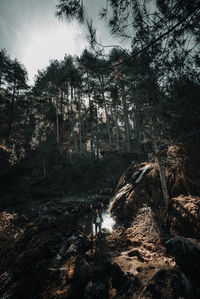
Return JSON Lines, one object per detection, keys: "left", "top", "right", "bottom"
{"left": 0, "top": 0, "right": 200, "bottom": 299}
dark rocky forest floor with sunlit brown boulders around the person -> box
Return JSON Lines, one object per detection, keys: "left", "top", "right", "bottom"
{"left": 0, "top": 146, "right": 200, "bottom": 299}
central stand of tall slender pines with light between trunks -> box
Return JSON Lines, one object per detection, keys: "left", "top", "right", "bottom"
{"left": 33, "top": 49, "right": 148, "bottom": 157}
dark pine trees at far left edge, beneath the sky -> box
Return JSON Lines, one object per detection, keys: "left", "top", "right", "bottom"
{"left": 0, "top": 49, "right": 30, "bottom": 163}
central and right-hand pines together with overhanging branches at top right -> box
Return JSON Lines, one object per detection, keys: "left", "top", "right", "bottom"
{"left": 30, "top": 0, "right": 200, "bottom": 163}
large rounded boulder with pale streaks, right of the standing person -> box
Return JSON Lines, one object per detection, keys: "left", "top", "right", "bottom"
{"left": 111, "top": 163, "right": 164, "bottom": 220}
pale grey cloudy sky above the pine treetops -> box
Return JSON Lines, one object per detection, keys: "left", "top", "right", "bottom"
{"left": 0, "top": 0, "right": 125, "bottom": 84}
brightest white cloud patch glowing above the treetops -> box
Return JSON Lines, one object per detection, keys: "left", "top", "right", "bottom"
{"left": 21, "top": 22, "right": 87, "bottom": 83}
